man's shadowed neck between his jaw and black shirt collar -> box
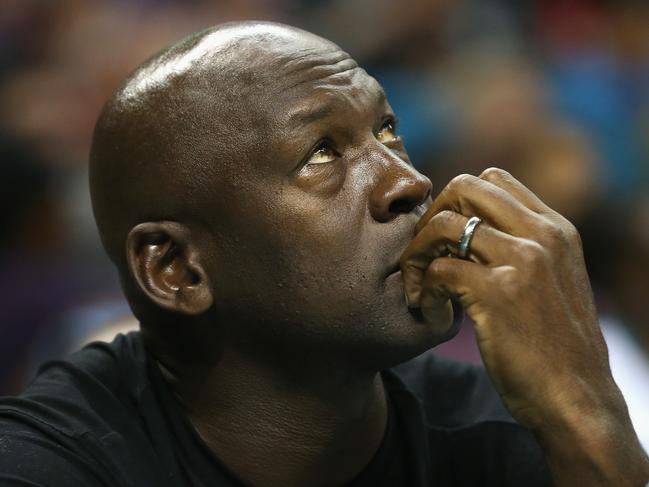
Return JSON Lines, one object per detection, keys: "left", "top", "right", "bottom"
{"left": 163, "top": 346, "right": 387, "bottom": 486}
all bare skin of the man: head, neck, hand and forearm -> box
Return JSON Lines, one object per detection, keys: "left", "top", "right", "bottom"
{"left": 91, "top": 23, "right": 649, "bottom": 486}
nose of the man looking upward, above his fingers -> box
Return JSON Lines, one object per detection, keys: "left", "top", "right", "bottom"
{"left": 370, "top": 154, "right": 433, "bottom": 223}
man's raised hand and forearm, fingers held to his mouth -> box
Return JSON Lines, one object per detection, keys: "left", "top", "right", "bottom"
{"left": 401, "top": 169, "right": 646, "bottom": 487}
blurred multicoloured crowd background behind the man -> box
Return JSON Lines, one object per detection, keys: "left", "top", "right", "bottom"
{"left": 0, "top": 0, "right": 649, "bottom": 448}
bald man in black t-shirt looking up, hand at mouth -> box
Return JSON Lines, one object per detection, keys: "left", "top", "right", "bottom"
{"left": 0, "top": 23, "right": 649, "bottom": 486}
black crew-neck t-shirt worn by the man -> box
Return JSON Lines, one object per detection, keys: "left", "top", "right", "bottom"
{"left": 0, "top": 332, "right": 550, "bottom": 487}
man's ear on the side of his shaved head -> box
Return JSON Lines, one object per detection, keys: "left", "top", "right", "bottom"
{"left": 126, "top": 221, "right": 214, "bottom": 315}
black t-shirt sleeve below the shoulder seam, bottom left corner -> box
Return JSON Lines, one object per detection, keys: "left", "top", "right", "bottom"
{"left": 0, "top": 419, "right": 109, "bottom": 487}
